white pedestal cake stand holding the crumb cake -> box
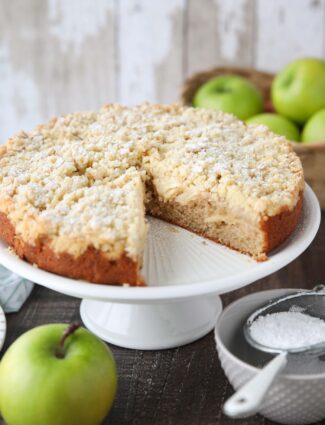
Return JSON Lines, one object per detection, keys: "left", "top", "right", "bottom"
{"left": 0, "top": 186, "right": 320, "bottom": 349}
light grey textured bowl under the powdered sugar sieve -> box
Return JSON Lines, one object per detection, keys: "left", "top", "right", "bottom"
{"left": 215, "top": 289, "right": 325, "bottom": 424}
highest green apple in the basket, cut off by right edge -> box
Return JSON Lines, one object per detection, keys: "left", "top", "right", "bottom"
{"left": 271, "top": 58, "right": 325, "bottom": 124}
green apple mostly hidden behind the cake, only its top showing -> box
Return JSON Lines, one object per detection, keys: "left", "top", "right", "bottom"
{"left": 246, "top": 113, "right": 300, "bottom": 142}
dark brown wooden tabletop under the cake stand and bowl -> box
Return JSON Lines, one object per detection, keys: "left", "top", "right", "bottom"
{"left": 0, "top": 214, "right": 325, "bottom": 425}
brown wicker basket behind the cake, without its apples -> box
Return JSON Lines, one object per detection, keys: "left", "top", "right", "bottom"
{"left": 181, "top": 67, "right": 325, "bottom": 210}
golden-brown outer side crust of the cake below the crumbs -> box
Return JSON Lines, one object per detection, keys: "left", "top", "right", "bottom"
{"left": 0, "top": 191, "right": 303, "bottom": 286}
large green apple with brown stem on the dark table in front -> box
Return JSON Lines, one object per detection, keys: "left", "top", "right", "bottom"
{"left": 0, "top": 324, "right": 117, "bottom": 425}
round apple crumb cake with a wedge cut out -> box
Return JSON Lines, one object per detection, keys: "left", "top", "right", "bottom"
{"left": 0, "top": 104, "right": 304, "bottom": 285}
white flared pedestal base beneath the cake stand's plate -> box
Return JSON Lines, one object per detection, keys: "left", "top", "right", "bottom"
{"left": 80, "top": 295, "right": 222, "bottom": 350}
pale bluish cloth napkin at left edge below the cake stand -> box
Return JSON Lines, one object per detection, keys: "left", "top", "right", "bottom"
{"left": 0, "top": 266, "right": 34, "bottom": 313}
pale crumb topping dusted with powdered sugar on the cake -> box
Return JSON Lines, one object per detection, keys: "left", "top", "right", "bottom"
{"left": 0, "top": 104, "right": 303, "bottom": 259}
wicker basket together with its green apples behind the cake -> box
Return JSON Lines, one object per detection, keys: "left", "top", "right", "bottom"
{"left": 181, "top": 58, "right": 325, "bottom": 209}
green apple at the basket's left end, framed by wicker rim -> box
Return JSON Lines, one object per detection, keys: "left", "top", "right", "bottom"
{"left": 193, "top": 75, "right": 263, "bottom": 120}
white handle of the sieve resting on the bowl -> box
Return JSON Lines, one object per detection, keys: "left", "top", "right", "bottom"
{"left": 223, "top": 352, "right": 287, "bottom": 418}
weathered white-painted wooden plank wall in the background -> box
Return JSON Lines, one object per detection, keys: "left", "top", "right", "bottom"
{"left": 0, "top": 0, "right": 325, "bottom": 142}
